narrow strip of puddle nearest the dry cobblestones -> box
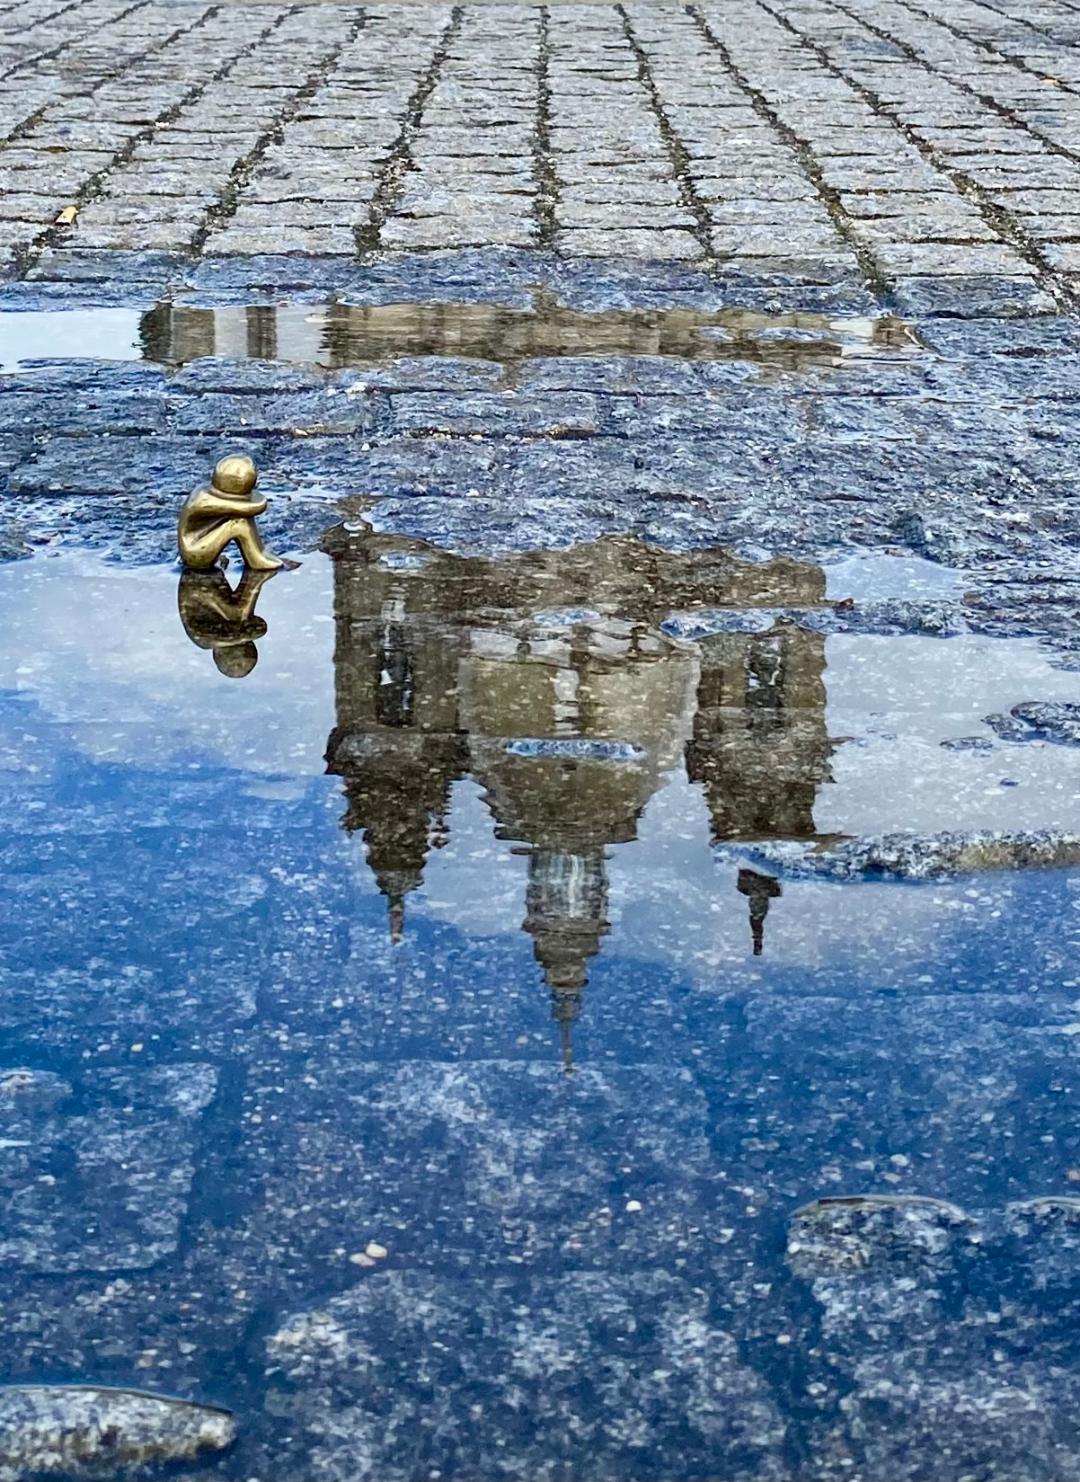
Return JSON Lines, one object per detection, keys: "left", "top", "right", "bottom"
{"left": 0, "top": 295, "right": 920, "bottom": 371}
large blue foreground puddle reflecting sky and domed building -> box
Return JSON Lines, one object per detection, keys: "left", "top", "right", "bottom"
{"left": 0, "top": 531, "right": 1080, "bottom": 1482}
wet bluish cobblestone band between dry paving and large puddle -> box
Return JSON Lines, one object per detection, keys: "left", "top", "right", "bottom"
{"left": 0, "top": 291, "right": 1080, "bottom": 643}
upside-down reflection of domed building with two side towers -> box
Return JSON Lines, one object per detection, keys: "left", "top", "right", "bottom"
{"left": 327, "top": 531, "right": 828, "bottom": 1054}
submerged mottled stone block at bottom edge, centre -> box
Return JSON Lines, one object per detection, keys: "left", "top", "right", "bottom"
{"left": 253, "top": 1272, "right": 788, "bottom": 1482}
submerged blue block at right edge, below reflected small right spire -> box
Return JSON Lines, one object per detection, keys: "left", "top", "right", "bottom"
{"left": 701, "top": 990, "right": 1080, "bottom": 1208}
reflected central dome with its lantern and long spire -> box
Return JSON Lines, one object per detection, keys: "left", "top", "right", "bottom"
{"left": 461, "top": 611, "right": 698, "bottom": 1069}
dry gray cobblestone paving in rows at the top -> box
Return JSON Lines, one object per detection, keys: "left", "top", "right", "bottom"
{"left": 0, "top": 0, "right": 1080, "bottom": 302}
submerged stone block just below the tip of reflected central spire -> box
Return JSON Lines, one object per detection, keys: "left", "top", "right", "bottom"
{"left": 231, "top": 1060, "right": 729, "bottom": 1270}
